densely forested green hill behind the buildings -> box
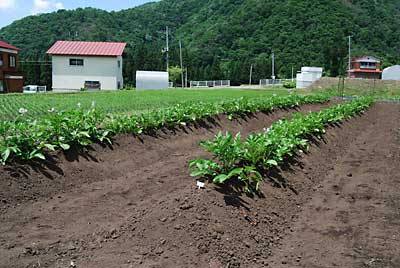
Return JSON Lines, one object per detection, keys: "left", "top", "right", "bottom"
{"left": 0, "top": 0, "right": 400, "bottom": 86}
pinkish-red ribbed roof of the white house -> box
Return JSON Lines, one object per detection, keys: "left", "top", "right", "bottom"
{"left": 47, "top": 41, "right": 126, "bottom": 56}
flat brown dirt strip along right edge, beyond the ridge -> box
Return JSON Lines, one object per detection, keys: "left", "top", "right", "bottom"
{"left": 270, "top": 101, "right": 400, "bottom": 268}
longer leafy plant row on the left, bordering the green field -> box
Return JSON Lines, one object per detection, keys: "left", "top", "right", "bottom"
{"left": 0, "top": 95, "right": 329, "bottom": 164}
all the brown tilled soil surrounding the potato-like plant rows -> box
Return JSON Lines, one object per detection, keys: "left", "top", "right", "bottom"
{"left": 0, "top": 103, "right": 400, "bottom": 268}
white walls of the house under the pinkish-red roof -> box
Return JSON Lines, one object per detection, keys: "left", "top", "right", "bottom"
{"left": 52, "top": 55, "right": 123, "bottom": 91}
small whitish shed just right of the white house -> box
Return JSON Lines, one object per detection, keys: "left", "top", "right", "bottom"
{"left": 136, "top": 71, "right": 169, "bottom": 90}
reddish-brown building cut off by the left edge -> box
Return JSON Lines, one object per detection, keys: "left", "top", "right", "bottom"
{"left": 0, "top": 41, "right": 24, "bottom": 93}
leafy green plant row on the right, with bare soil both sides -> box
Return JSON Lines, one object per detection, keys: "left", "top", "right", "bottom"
{"left": 189, "top": 98, "right": 374, "bottom": 193}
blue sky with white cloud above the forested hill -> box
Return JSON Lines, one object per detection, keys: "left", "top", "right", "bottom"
{"left": 0, "top": 0, "right": 154, "bottom": 28}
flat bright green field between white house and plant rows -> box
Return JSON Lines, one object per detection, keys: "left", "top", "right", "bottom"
{"left": 0, "top": 89, "right": 288, "bottom": 120}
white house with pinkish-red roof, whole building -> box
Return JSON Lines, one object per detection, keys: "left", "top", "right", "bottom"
{"left": 47, "top": 41, "right": 126, "bottom": 92}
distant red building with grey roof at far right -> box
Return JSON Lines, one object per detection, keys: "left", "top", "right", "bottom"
{"left": 348, "top": 56, "right": 382, "bottom": 79}
